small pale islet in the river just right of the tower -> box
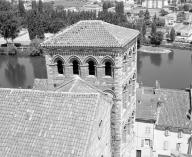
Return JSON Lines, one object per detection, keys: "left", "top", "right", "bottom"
{"left": 138, "top": 46, "right": 171, "bottom": 54}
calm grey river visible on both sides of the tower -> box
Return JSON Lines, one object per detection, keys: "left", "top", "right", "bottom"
{"left": 0, "top": 49, "right": 192, "bottom": 89}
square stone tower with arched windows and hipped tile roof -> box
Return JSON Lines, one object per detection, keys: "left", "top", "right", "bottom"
{"left": 40, "top": 20, "right": 139, "bottom": 157}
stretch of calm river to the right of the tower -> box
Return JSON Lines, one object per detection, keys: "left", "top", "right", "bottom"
{"left": 137, "top": 49, "right": 192, "bottom": 89}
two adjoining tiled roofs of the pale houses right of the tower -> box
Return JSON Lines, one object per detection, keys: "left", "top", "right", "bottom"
{"left": 136, "top": 87, "right": 192, "bottom": 132}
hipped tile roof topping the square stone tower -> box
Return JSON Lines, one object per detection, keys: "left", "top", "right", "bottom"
{"left": 41, "top": 20, "right": 139, "bottom": 47}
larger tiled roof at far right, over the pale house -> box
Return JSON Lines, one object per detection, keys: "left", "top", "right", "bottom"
{"left": 157, "top": 89, "right": 192, "bottom": 131}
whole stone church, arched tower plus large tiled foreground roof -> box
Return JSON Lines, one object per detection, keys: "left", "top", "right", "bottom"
{"left": 0, "top": 20, "right": 139, "bottom": 157}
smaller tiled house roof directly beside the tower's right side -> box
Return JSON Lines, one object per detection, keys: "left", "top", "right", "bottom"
{"left": 136, "top": 88, "right": 157, "bottom": 122}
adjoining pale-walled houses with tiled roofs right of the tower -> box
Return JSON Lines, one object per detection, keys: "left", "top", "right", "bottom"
{"left": 135, "top": 84, "right": 192, "bottom": 157}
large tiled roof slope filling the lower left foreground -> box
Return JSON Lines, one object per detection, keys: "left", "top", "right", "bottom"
{"left": 0, "top": 88, "right": 99, "bottom": 157}
